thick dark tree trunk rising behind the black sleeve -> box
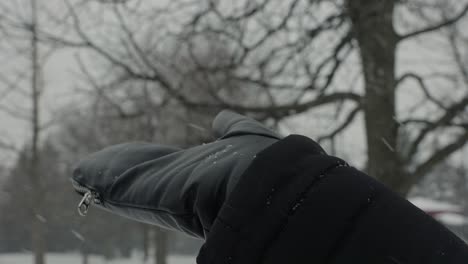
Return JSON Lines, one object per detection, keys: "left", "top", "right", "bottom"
{"left": 347, "top": 0, "right": 409, "bottom": 195}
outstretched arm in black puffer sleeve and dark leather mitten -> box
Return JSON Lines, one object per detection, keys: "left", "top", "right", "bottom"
{"left": 73, "top": 112, "right": 468, "bottom": 264}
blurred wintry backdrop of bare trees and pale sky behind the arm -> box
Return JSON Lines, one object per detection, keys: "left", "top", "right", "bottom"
{"left": 0, "top": 0, "right": 468, "bottom": 263}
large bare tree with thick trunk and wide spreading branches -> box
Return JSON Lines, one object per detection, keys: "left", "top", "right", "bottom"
{"left": 44, "top": 0, "right": 468, "bottom": 194}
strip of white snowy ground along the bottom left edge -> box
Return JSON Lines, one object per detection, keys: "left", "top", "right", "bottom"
{"left": 0, "top": 253, "right": 196, "bottom": 264}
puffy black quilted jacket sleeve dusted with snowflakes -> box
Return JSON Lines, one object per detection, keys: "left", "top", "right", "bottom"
{"left": 197, "top": 135, "right": 468, "bottom": 264}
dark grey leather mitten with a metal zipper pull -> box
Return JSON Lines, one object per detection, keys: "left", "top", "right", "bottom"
{"left": 72, "top": 111, "right": 279, "bottom": 238}
